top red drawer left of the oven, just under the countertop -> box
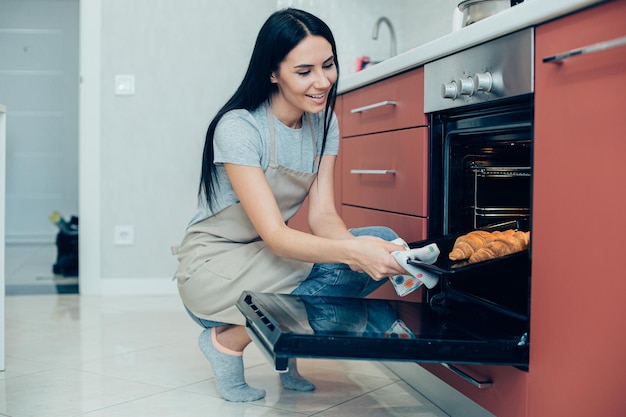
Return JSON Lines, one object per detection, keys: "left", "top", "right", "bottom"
{"left": 341, "top": 68, "right": 427, "bottom": 136}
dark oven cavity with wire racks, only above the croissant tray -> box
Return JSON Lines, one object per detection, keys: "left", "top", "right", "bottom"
{"left": 429, "top": 96, "right": 533, "bottom": 237}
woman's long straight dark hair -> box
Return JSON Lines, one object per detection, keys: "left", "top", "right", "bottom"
{"left": 198, "top": 8, "right": 339, "bottom": 207}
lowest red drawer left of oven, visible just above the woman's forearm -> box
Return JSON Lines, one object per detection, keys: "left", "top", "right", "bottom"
{"left": 341, "top": 206, "right": 428, "bottom": 242}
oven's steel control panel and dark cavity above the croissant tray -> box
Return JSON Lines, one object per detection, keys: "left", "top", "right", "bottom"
{"left": 424, "top": 29, "right": 533, "bottom": 237}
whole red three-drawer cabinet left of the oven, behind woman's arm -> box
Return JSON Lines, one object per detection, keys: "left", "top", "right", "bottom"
{"left": 339, "top": 68, "right": 428, "bottom": 301}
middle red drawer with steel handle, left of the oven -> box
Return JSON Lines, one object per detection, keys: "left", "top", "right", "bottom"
{"left": 341, "top": 128, "right": 428, "bottom": 217}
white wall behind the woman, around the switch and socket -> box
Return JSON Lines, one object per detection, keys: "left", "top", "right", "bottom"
{"left": 80, "top": 0, "right": 455, "bottom": 294}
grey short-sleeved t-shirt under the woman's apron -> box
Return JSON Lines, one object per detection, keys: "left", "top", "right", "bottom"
{"left": 189, "top": 105, "right": 339, "bottom": 225}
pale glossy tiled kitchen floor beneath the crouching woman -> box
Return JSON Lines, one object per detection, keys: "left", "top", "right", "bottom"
{"left": 0, "top": 244, "right": 446, "bottom": 417}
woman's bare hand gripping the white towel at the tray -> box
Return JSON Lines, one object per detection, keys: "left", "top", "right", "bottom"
{"left": 348, "top": 236, "right": 408, "bottom": 281}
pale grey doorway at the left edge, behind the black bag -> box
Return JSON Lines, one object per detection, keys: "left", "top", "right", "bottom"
{"left": 0, "top": 0, "right": 79, "bottom": 295}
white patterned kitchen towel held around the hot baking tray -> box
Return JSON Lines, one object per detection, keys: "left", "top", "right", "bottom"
{"left": 390, "top": 238, "right": 440, "bottom": 297}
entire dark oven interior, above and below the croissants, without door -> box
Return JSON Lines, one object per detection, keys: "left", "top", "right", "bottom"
{"left": 424, "top": 94, "right": 533, "bottom": 320}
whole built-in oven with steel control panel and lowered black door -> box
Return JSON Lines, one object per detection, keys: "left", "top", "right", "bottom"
{"left": 237, "top": 29, "right": 534, "bottom": 370}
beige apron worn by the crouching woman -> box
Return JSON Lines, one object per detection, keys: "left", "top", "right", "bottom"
{"left": 172, "top": 105, "right": 316, "bottom": 324}
